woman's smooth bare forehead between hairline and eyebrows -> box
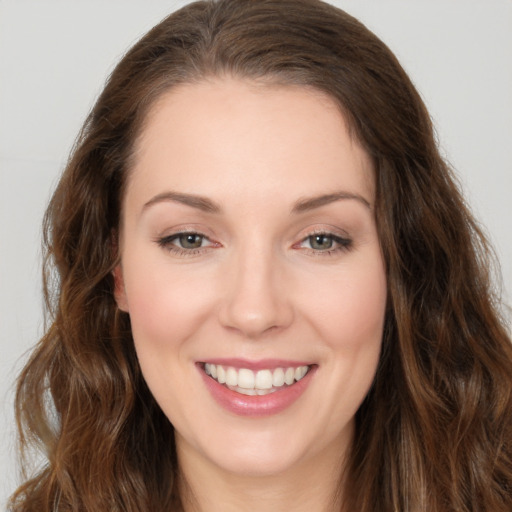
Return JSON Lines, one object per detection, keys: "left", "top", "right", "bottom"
{"left": 128, "top": 78, "right": 374, "bottom": 208}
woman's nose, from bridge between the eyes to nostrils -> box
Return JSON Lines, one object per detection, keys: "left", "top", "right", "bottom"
{"left": 219, "top": 245, "right": 294, "bottom": 339}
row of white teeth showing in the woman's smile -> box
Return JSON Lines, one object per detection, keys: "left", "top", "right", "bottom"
{"left": 204, "top": 363, "right": 309, "bottom": 395}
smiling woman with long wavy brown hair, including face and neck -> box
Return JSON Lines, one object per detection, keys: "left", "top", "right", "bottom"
{"left": 11, "top": 0, "right": 512, "bottom": 511}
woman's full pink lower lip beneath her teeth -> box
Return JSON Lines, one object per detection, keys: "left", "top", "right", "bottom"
{"left": 198, "top": 366, "right": 316, "bottom": 416}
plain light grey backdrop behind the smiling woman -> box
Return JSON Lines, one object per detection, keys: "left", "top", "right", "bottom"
{"left": 0, "top": 0, "right": 512, "bottom": 508}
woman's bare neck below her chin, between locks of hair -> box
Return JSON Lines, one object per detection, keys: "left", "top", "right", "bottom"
{"left": 178, "top": 432, "right": 346, "bottom": 512}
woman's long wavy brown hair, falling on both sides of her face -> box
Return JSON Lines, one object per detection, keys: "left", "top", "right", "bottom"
{"left": 10, "top": 0, "right": 512, "bottom": 512}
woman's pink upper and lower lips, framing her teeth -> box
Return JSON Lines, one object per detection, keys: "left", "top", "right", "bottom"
{"left": 197, "top": 359, "right": 317, "bottom": 417}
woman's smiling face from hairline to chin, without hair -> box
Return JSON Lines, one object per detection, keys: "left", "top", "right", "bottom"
{"left": 116, "top": 79, "right": 386, "bottom": 475}
